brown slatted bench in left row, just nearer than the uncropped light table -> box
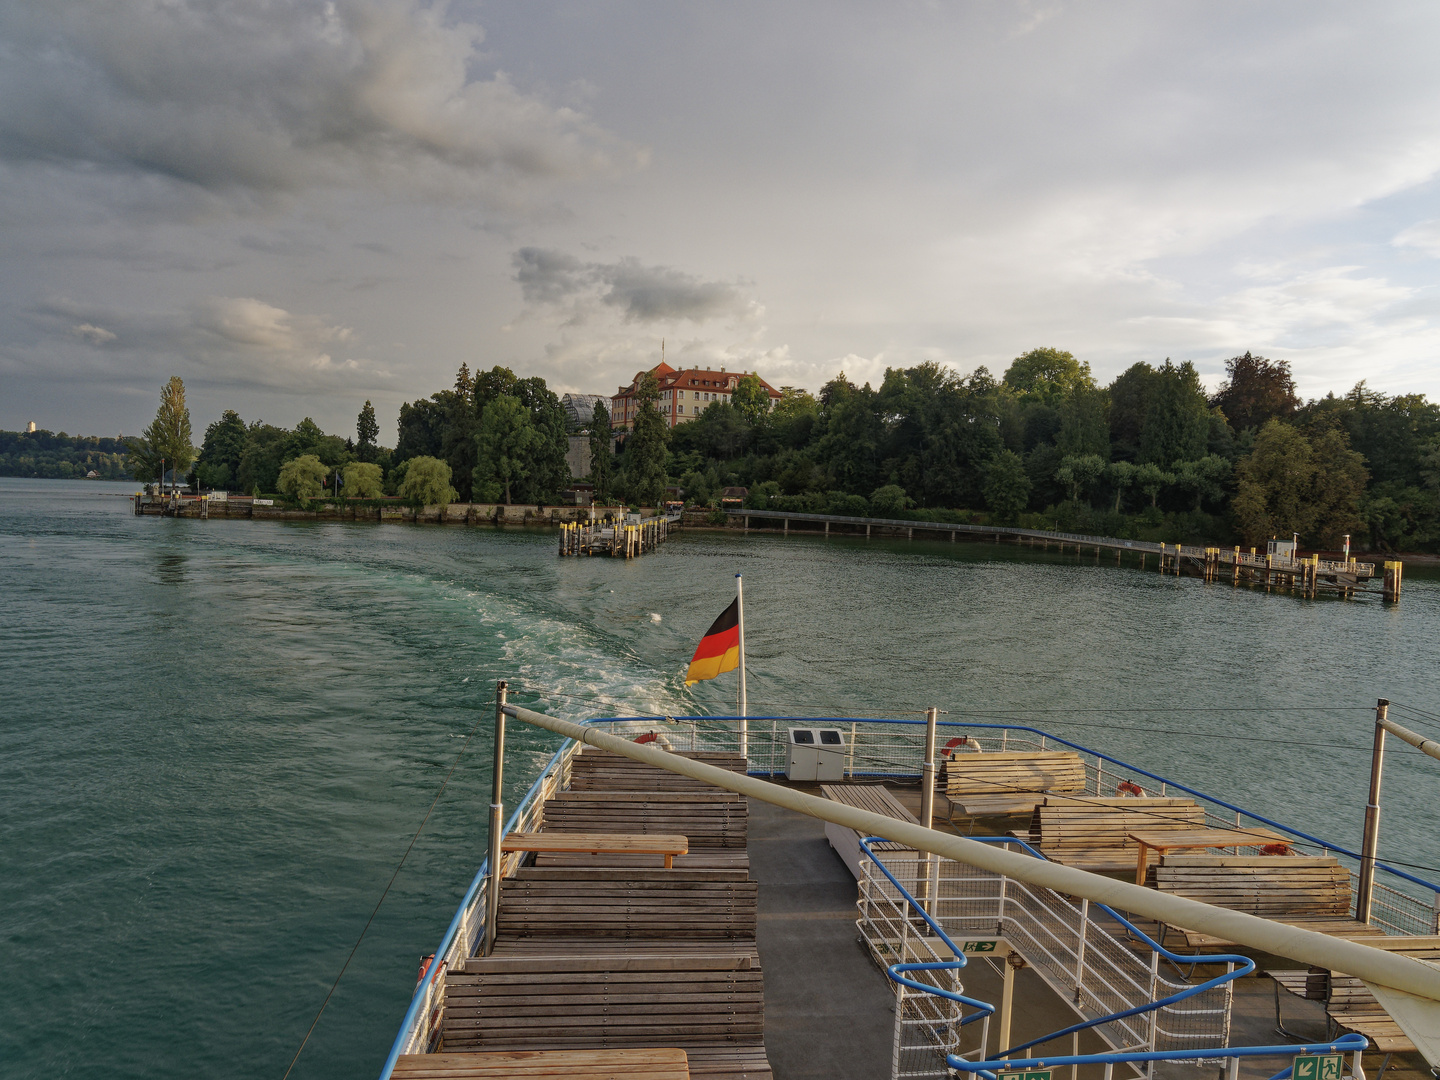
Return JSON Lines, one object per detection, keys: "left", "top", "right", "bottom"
{"left": 497, "top": 873, "right": 759, "bottom": 940}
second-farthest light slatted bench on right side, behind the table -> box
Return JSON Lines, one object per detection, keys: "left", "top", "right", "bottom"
{"left": 1028, "top": 795, "right": 1205, "bottom": 873}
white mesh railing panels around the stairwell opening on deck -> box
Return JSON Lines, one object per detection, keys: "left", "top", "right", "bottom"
{"left": 857, "top": 851, "right": 1234, "bottom": 1079}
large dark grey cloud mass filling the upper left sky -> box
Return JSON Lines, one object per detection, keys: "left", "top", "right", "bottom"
{"left": 0, "top": 0, "right": 624, "bottom": 193}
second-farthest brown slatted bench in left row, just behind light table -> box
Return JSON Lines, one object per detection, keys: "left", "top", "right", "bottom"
{"left": 544, "top": 789, "right": 749, "bottom": 851}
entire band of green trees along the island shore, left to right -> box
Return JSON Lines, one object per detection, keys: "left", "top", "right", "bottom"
{"left": 118, "top": 348, "right": 1440, "bottom": 550}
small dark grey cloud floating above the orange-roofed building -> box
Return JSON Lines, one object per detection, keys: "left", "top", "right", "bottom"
{"left": 511, "top": 248, "right": 753, "bottom": 323}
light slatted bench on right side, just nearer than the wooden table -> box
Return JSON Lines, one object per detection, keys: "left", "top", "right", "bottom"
{"left": 1151, "top": 855, "right": 1382, "bottom": 948}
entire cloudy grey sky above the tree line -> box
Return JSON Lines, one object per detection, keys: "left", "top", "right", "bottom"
{"left": 0, "top": 0, "right": 1440, "bottom": 445}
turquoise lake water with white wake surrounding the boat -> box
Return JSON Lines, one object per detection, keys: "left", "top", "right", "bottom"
{"left": 0, "top": 480, "right": 1440, "bottom": 1077}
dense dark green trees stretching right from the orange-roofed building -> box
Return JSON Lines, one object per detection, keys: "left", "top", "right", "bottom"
{"left": 670, "top": 348, "right": 1440, "bottom": 550}
